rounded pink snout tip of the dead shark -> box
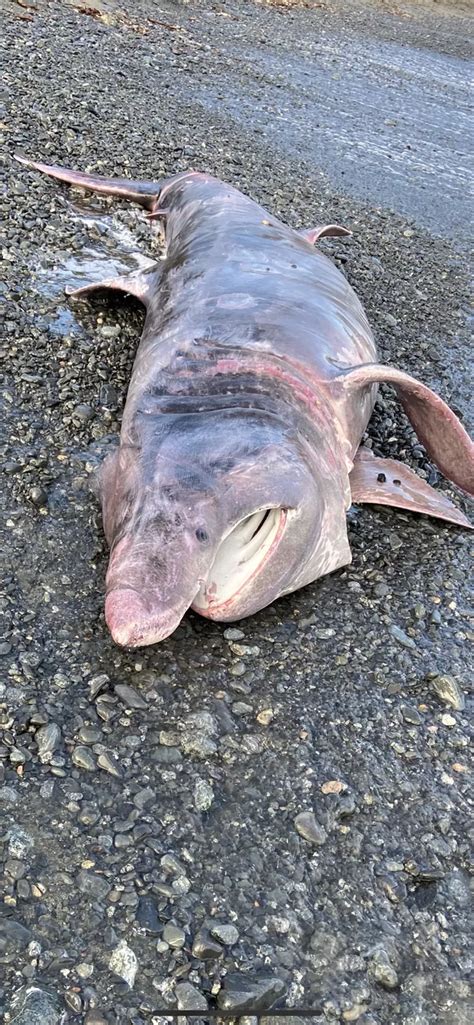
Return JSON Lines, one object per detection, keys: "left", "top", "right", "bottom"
{"left": 106, "top": 588, "right": 186, "bottom": 648}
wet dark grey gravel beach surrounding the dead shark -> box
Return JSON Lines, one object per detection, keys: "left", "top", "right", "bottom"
{"left": 0, "top": 0, "right": 472, "bottom": 1025}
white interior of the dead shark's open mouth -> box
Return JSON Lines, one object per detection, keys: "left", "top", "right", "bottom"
{"left": 193, "top": 508, "right": 284, "bottom": 610}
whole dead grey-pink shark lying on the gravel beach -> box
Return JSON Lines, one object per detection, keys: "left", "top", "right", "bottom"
{"left": 16, "top": 159, "right": 474, "bottom": 646}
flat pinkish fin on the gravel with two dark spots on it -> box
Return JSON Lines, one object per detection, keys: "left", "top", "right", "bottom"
{"left": 349, "top": 446, "right": 473, "bottom": 530}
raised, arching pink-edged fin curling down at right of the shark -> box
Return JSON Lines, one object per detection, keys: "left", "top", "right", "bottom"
{"left": 335, "top": 363, "right": 474, "bottom": 495}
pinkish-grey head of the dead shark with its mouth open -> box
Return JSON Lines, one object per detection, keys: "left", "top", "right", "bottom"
{"left": 97, "top": 411, "right": 349, "bottom": 647}
